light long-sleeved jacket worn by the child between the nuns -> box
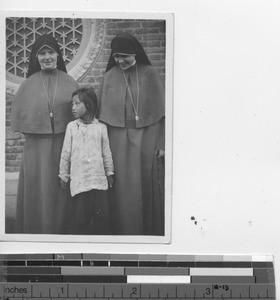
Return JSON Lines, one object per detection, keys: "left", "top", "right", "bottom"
{"left": 59, "top": 119, "right": 114, "bottom": 196}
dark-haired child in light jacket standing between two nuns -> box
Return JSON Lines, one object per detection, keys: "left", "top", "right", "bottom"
{"left": 59, "top": 88, "right": 114, "bottom": 234}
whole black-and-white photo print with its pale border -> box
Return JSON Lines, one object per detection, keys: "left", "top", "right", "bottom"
{"left": 3, "top": 14, "right": 172, "bottom": 242}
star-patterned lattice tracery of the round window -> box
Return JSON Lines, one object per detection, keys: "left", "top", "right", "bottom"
{"left": 6, "top": 18, "right": 83, "bottom": 78}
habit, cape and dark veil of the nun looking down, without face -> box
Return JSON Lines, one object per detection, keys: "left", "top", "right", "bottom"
{"left": 99, "top": 33, "right": 165, "bottom": 235}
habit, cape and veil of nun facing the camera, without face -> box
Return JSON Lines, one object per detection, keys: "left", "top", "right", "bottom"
{"left": 11, "top": 34, "right": 78, "bottom": 234}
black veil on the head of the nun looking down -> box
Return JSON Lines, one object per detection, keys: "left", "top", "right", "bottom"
{"left": 106, "top": 33, "right": 151, "bottom": 72}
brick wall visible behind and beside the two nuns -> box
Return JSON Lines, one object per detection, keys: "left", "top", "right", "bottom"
{"left": 6, "top": 19, "right": 165, "bottom": 172}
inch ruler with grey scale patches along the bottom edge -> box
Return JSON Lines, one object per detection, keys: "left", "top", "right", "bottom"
{"left": 0, "top": 253, "right": 276, "bottom": 300}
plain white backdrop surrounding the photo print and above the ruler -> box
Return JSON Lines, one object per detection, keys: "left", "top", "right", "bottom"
{"left": 0, "top": 0, "right": 280, "bottom": 293}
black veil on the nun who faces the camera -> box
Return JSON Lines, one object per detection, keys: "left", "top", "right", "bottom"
{"left": 27, "top": 34, "right": 67, "bottom": 77}
